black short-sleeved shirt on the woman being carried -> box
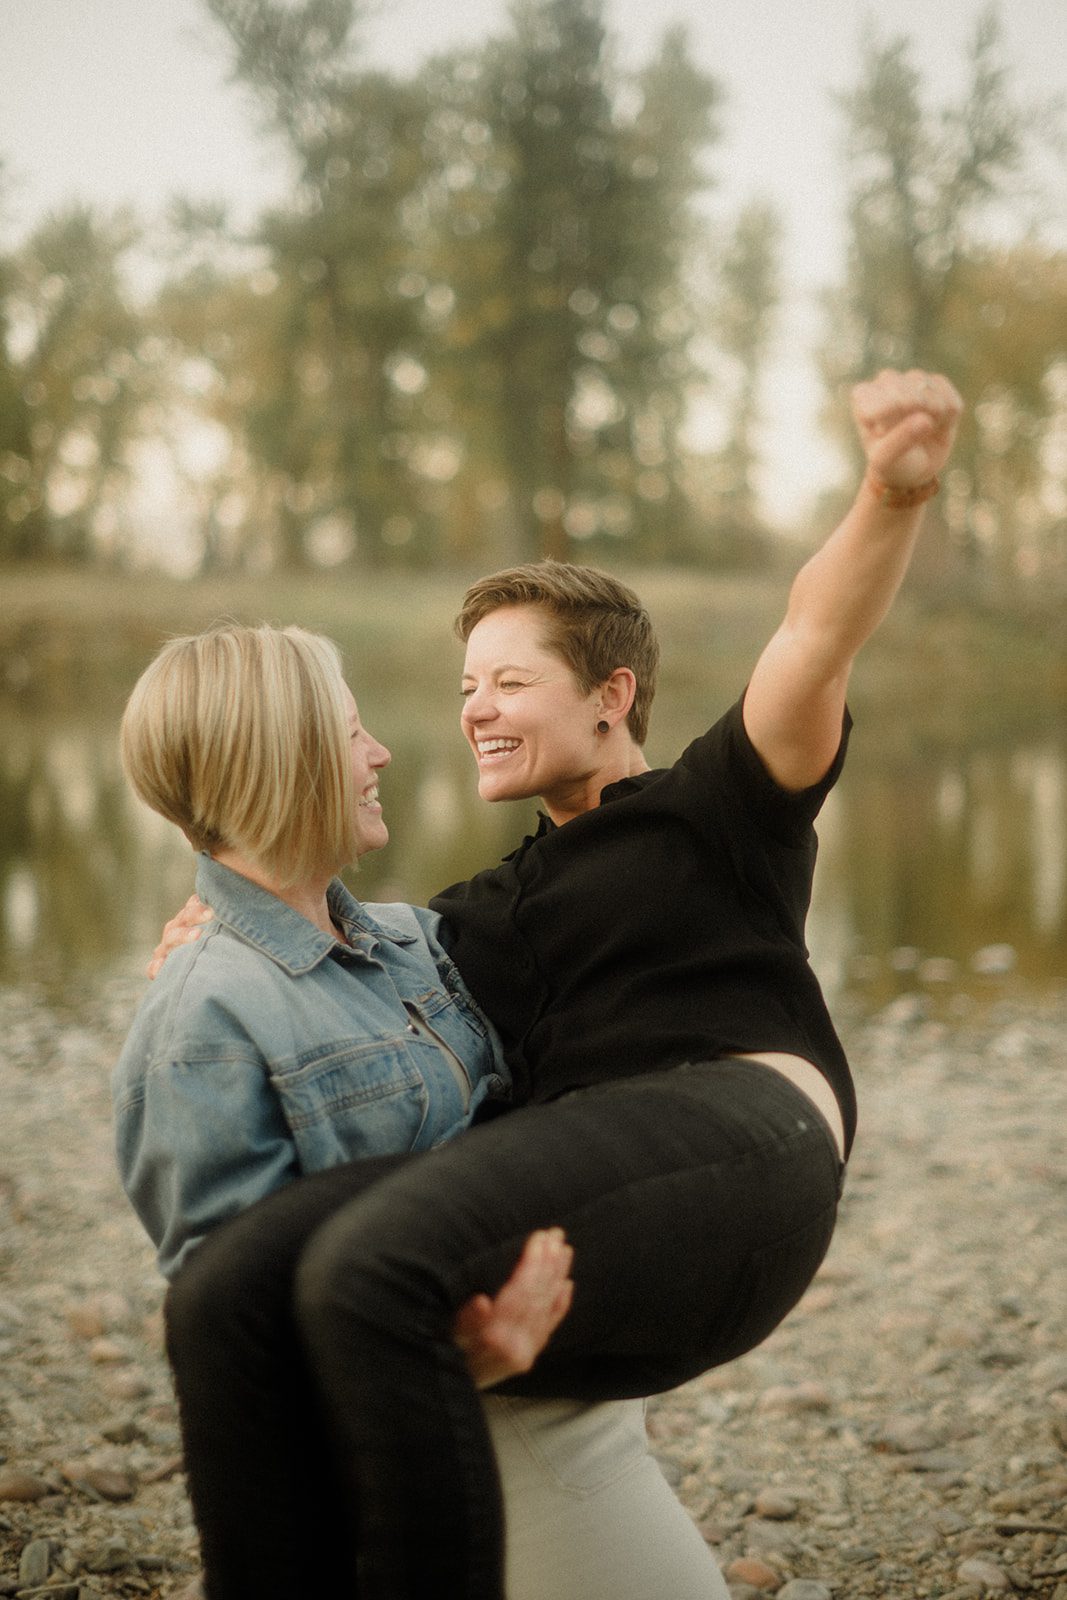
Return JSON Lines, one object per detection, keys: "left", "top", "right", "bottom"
{"left": 430, "top": 701, "right": 856, "bottom": 1146}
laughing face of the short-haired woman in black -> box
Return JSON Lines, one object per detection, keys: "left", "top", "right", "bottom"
{"left": 462, "top": 606, "right": 609, "bottom": 821}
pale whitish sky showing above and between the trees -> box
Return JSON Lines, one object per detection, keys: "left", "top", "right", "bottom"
{"left": 0, "top": 0, "right": 1067, "bottom": 517}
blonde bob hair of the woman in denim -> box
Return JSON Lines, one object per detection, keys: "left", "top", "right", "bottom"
{"left": 120, "top": 624, "right": 357, "bottom": 885}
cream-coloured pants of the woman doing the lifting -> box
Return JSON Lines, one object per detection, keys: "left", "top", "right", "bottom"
{"left": 485, "top": 1395, "right": 729, "bottom": 1600}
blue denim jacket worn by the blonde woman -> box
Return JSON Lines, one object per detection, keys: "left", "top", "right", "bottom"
{"left": 112, "top": 856, "right": 507, "bottom": 1277}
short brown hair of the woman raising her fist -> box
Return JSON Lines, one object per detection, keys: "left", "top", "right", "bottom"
{"left": 454, "top": 562, "right": 659, "bottom": 744}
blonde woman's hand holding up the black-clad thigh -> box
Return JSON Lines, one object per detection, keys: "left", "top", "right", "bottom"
{"left": 453, "top": 1227, "right": 574, "bottom": 1389}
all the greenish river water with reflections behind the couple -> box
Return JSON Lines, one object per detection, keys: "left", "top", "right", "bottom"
{"left": 0, "top": 693, "right": 1067, "bottom": 1005}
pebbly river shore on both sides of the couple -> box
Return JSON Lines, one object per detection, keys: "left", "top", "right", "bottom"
{"left": 0, "top": 978, "right": 1067, "bottom": 1600}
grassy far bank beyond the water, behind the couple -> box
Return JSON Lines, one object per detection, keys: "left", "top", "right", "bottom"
{"left": 0, "top": 568, "right": 1067, "bottom": 725}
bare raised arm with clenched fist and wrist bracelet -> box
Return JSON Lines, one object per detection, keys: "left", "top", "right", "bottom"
{"left": 744, "top": 371, "right": 963, "bottom": 789}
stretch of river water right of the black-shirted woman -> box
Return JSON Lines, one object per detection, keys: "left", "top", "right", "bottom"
{"left": 809, "top": 733, "right": 1067, "bottom": 1003}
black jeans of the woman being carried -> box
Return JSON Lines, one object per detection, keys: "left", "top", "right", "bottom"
{"left": 166, "top": 1061, "right": 841, "bottom": 1600}
